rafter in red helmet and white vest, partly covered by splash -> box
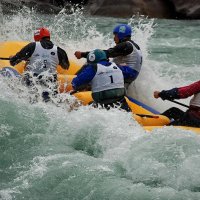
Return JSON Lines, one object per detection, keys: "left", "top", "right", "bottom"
{"left": 10, "top": 28, "right": 69, "bottom": 101}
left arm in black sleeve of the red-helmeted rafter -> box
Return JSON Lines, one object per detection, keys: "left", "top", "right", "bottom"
{"left": 10, "top": 42, "right": 36, "bottom": 66}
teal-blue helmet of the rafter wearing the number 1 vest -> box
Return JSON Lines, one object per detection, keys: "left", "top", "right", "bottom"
{"left": 87, "top": 49, "right": 107, "bottom": 63}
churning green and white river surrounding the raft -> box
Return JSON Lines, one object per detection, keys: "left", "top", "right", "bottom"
{"left": 0, "top": 6, "right": 200, "bottom": 200}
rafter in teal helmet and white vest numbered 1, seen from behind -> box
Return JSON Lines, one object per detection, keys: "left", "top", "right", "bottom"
{"left": 72, "top": 49, "right": 130, "bottom": 111}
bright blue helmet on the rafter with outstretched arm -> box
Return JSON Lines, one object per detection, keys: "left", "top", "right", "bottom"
{"left": 113, "top": 24, "right": 132, "bottom": 40}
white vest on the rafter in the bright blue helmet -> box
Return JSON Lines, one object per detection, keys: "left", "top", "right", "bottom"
{"left": 113, "top": 41, "right": 142, "bottom": 73}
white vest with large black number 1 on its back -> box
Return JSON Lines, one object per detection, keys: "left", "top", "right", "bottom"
{"left": 91, "top": 63, "right": 124, "bottom": 92}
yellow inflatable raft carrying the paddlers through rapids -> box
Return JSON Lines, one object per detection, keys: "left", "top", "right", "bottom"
{"left": 0, "top": 41, "right": 200, "bottom": 133}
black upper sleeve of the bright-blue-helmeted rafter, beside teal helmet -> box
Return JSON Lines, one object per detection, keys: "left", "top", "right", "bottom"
{"left": 104, "top": 42, "right": 133, "bottom": 58}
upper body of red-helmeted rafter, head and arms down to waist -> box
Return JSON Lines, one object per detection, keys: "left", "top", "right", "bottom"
{"left": 10, "top": 28, "right": 69, "bottom": 73}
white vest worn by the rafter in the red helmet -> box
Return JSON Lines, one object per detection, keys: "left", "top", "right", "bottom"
{"left": 27, "top": 42, "right": 59, "bottom": 74}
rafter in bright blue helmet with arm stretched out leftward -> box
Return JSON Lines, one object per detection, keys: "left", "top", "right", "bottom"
{"left": 74, "top": 24, "right": 142, "bottom": 88}
